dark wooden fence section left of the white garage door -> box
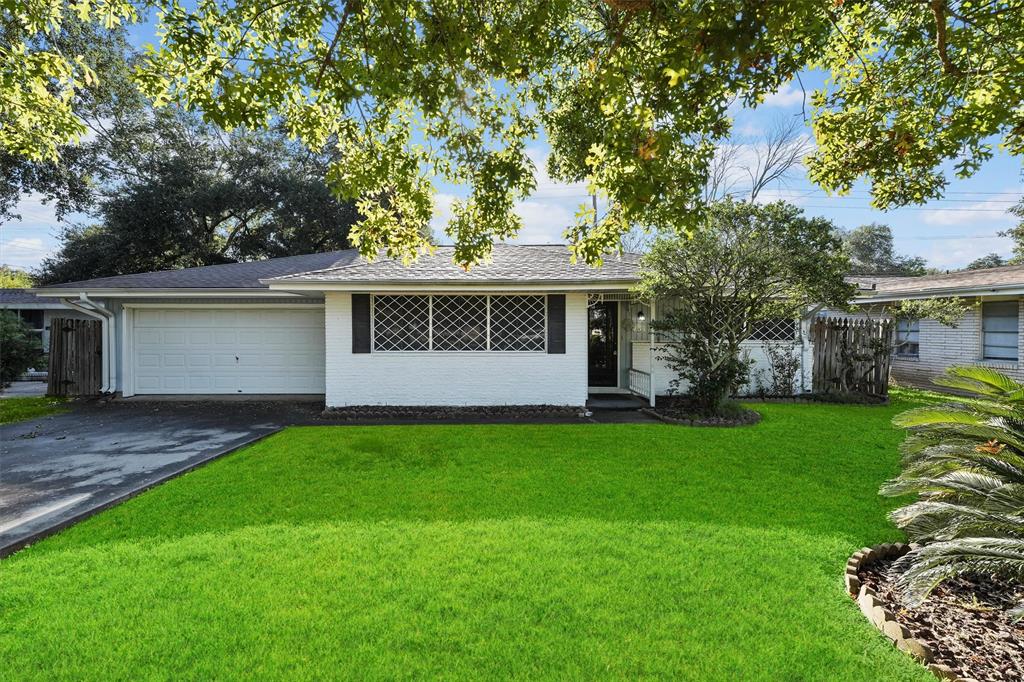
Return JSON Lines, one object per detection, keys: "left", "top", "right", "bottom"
{"left": 46, "top": 317, "right": 103, "bottom": 395}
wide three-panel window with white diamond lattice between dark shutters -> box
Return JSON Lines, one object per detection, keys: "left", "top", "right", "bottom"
{"left": 373, "top": 295, "right": 547, "bottom": 351}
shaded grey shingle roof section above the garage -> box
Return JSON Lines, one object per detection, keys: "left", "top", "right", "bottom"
{"left": 36, "top": 249, "right": 358, "bottom": 289}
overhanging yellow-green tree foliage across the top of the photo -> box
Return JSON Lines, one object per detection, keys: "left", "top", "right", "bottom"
{"left": 8, "top": 0, "right": 1024, "bottom": 264}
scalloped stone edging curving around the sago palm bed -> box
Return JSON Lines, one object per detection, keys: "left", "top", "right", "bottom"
{"left": 844, "top": 543, "right": 968, "bottom": 682}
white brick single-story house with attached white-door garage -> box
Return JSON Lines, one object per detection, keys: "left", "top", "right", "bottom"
{"left": 37, "top": 245, "right": 809, "bottom": 407}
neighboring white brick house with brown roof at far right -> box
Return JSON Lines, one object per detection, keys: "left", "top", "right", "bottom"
{"left": 857, "top": 265, "right": 1024, "bottom": 386}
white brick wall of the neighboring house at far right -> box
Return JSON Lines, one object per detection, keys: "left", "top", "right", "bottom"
{"left": 892, "top": 300, "right": 1024, "bottom": 385}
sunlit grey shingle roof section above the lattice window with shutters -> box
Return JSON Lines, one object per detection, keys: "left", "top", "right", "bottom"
{"left": 273, "top": 244, "right": 640, "bottom": 285}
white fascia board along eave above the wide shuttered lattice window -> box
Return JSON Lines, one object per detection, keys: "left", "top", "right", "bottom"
{"left": 261, "top": 280, "right": 637, "bottom": 293}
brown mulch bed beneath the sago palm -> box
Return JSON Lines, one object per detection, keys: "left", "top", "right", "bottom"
{"left": 859, "top": 560, "right": 1024, "bottom": 682}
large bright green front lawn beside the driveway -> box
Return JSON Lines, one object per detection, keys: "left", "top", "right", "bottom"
{"left": 0, "top": 404, "right": 931, "bottom": 681}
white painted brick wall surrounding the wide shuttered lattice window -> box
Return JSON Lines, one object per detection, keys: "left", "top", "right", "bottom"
{"left": 325, "top": 293, "right": 587, "bottom": 407}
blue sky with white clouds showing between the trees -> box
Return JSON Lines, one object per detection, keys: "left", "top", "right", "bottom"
{"left": 0, "top": 27, "right": 1024, "bottom": 269}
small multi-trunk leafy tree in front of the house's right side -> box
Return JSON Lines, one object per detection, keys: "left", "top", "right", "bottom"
{"left": 637, "top": 200, "right": 854, "bottom": 413}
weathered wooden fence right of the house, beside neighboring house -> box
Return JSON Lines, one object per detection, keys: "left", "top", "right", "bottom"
{"left": 811, "top": 317, "right": 896, "bottom": 396}
